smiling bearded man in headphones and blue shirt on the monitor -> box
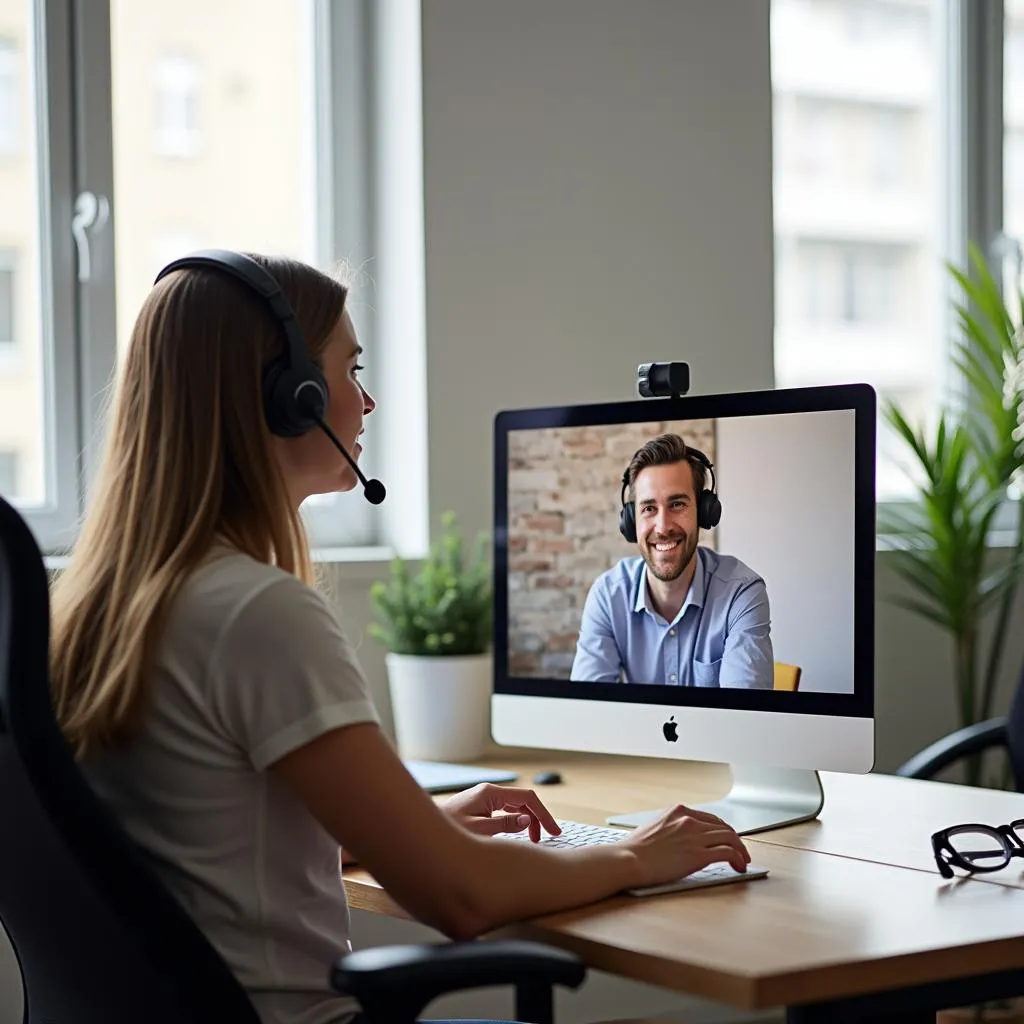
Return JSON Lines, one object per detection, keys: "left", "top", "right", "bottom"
{"left": 569, "top": 434, "right": 774, "bottom": 689}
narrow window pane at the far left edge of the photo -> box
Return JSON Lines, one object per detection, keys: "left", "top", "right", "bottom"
{"left": 0, "top": 0, "right": 49, "bottom": 509}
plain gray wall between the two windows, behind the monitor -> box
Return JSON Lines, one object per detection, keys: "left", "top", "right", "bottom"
{"left": 415, "top": 0, "right": 773, "bottom": 544}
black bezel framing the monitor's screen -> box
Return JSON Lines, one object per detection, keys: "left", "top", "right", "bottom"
{"left": 493, "top": 383, "right": 877, "bottom": 718}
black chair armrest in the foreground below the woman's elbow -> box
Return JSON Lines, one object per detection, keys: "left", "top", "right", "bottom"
{"left": 331, "top": 939, "right": 587, "bottom": 1024}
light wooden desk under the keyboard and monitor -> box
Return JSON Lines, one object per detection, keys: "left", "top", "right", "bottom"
{"left": 345, "top": 752, "right": 1024, "bottom": 1024}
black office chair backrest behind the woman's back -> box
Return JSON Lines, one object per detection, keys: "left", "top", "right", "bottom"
{"left": 0, "top": 498, "right": 260, "bottom": 1024}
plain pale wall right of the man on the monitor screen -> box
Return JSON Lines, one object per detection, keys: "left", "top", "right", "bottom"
{"left": 716, "top": 410, "right": 855, "bottom": 693}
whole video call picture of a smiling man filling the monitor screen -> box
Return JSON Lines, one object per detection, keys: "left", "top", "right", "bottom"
{"left": 507, "top": 410, "right": 855, "bottom": 693}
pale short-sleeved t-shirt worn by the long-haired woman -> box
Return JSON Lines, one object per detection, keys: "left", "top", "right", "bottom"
{"left": 83, "top": 549, "right": 377, "bottom": 1024}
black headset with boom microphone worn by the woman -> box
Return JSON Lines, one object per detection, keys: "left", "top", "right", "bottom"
{"left": 154, "top": 249, "right": 386, "bottom": 505}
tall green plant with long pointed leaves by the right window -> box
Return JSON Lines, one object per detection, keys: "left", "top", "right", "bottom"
{"left": 880, "top": 246, "right": 1024, "bottom": 785}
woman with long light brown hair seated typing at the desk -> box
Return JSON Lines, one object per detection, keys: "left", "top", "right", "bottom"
{"left": 52, "top": 257, "right": 750, "bottom": 1024}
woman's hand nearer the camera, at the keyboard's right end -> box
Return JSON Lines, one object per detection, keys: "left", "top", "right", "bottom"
{"left": 622, "top": 804, "right": 751, "bottom": 886}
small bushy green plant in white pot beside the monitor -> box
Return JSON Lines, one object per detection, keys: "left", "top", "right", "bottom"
{"left": 369, "top": 511, "right": 493, "bottom": 761}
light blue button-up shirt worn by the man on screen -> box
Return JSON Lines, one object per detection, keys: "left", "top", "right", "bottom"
{"left": 569, "top": 547, "right": 774, "bottom": 690}
